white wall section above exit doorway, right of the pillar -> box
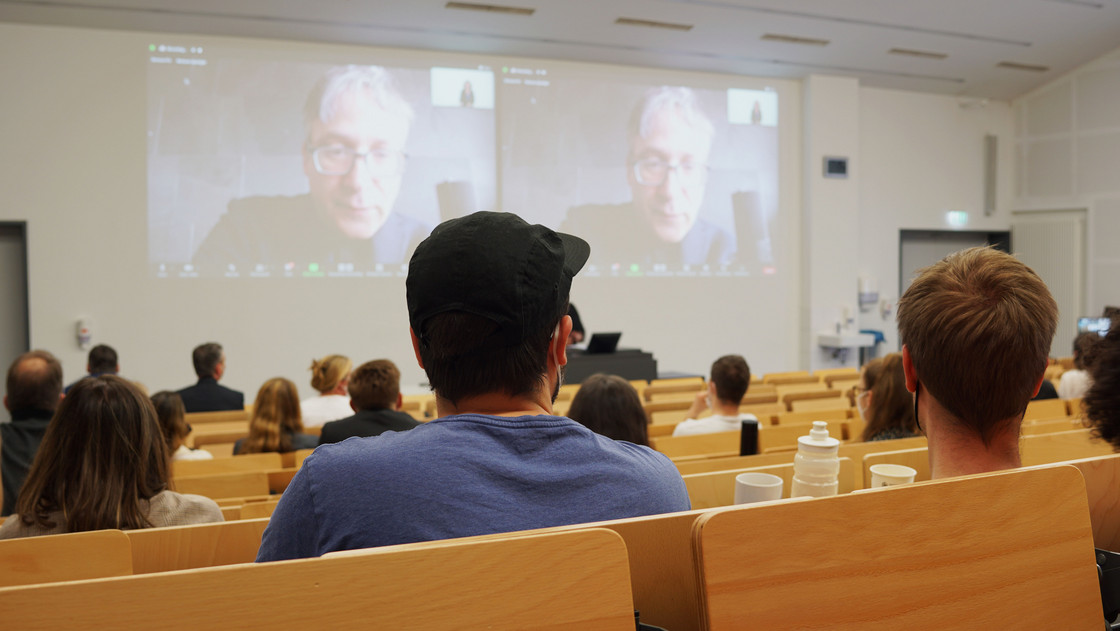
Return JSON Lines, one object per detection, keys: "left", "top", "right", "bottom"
{"left": 846, "top": 87, "right": 1015, "bottom": 354}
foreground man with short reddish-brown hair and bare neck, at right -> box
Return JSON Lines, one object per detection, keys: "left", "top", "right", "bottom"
{"left": 898, "top": 248, "right": 1057, "bottom": 479}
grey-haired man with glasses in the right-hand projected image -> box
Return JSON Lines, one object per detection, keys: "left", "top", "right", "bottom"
{"left": 561, "top": 86, "right": 735, "bottom": 265}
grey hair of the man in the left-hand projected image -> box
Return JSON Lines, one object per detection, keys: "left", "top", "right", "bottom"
{"left": 304, "top": 65, "right": 416, "bottom": 129}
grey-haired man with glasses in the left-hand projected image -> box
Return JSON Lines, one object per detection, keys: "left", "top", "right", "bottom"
{"left": 195, "top": 65, "right": 430, "bottom": 271}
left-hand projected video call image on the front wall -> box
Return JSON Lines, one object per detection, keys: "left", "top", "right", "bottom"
{"left": 148, "top": 56, "right": 497, "bottom": 277}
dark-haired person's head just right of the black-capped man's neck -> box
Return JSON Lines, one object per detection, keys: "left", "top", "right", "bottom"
{"left": 568, "top": 373, "right": 650, "bottom": 446}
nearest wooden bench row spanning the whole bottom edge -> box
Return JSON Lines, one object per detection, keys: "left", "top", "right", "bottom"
{"left": 0, "top": 456, "right": 1106, "bottom": 631}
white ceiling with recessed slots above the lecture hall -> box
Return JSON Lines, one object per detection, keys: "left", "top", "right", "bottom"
{"left": 0, "top": 0, "right": 1120, "bottom": 100}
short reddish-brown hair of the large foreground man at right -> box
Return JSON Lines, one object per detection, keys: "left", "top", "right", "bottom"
{"left": 898, "top": 248, "right": 1057, "bottom": 445}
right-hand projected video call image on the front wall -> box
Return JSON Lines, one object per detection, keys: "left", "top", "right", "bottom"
{"left": 500, "top": 68, "right": 778, "bottom": 276}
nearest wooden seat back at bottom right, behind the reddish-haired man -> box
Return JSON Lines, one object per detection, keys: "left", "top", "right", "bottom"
{"left": 693, "top": 466, "right": 1103, "bottom": 631}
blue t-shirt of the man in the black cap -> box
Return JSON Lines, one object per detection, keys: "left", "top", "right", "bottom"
{"left": 256, "top": 415, "right": 690, "bottom": 562}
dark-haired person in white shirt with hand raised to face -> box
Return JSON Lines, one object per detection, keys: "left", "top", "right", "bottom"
{"left": 673, "top": 355, "right": 758, "bottom": 436}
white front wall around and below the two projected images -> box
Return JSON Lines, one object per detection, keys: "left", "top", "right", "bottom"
{"left": 0, "top": 24, "right": 800, "bottom": 399}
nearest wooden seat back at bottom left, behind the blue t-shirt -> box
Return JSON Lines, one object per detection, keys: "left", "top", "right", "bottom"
{"left": 0, "top": 528, "right": 634, "bottom": 631}
